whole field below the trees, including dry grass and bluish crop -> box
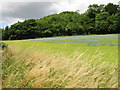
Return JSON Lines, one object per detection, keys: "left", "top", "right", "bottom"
{"left": 2, "top": 34, "right": 118, "bottom": 88}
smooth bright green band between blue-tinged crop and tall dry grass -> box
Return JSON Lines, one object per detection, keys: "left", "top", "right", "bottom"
{"left": 5, "top": 41, "right": 118, "bottom": 63}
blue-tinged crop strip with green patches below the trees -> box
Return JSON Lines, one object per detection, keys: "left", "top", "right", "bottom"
{"left": 30, "top": 34, "right": 118, "bottom": 46}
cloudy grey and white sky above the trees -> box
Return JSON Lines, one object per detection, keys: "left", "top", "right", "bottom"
{"left": 0, "top": 0, "right": 120, "bottom": 28}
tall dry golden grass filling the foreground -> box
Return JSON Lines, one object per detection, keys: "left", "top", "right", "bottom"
{"left": 2, "top": 47, "right": 118, "bottom": 88}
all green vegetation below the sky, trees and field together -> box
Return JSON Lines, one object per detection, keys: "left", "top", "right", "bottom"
{"left": 0, "top": 3, "right": 120, "bottom": 88}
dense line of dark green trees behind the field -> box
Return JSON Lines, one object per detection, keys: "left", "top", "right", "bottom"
{"left": 2, "top": 3, "right": 120, "bottom": 40}
